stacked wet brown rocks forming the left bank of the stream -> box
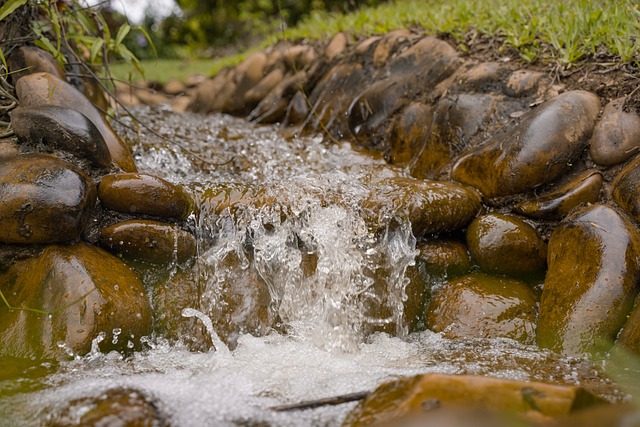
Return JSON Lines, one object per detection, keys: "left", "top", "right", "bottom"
{"left": 0, "top": 47, "right": 196, "bottom": 360}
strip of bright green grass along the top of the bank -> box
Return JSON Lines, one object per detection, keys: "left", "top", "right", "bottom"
{"left": 113, "top": 0, "right": 640, "bottom": 82}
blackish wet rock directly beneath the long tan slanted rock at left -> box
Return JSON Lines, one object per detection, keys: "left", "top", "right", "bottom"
{"left": 10, "top": 105, "right": 111, "bottom": 167}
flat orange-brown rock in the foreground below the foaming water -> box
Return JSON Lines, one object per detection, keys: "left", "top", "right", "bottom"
{"left": 342, "top": 374, "right": 602, "bottom": 427}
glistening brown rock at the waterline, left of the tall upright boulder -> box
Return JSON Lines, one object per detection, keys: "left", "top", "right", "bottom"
{"left": 427, "top": 273, "right": 537, "bottom": 344}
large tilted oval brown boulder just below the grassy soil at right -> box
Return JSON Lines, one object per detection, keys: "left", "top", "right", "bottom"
{"left": 451, "top": 91, "right": 600, "bottom": 197}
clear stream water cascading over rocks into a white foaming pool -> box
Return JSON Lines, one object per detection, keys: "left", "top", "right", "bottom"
{"left": 0, "top": 108, "right": 624, "bottom": 426}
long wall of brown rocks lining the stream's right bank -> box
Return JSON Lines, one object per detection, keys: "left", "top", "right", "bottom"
{"left": 129, "top": 30, "right": 640, "bottom": 362}
